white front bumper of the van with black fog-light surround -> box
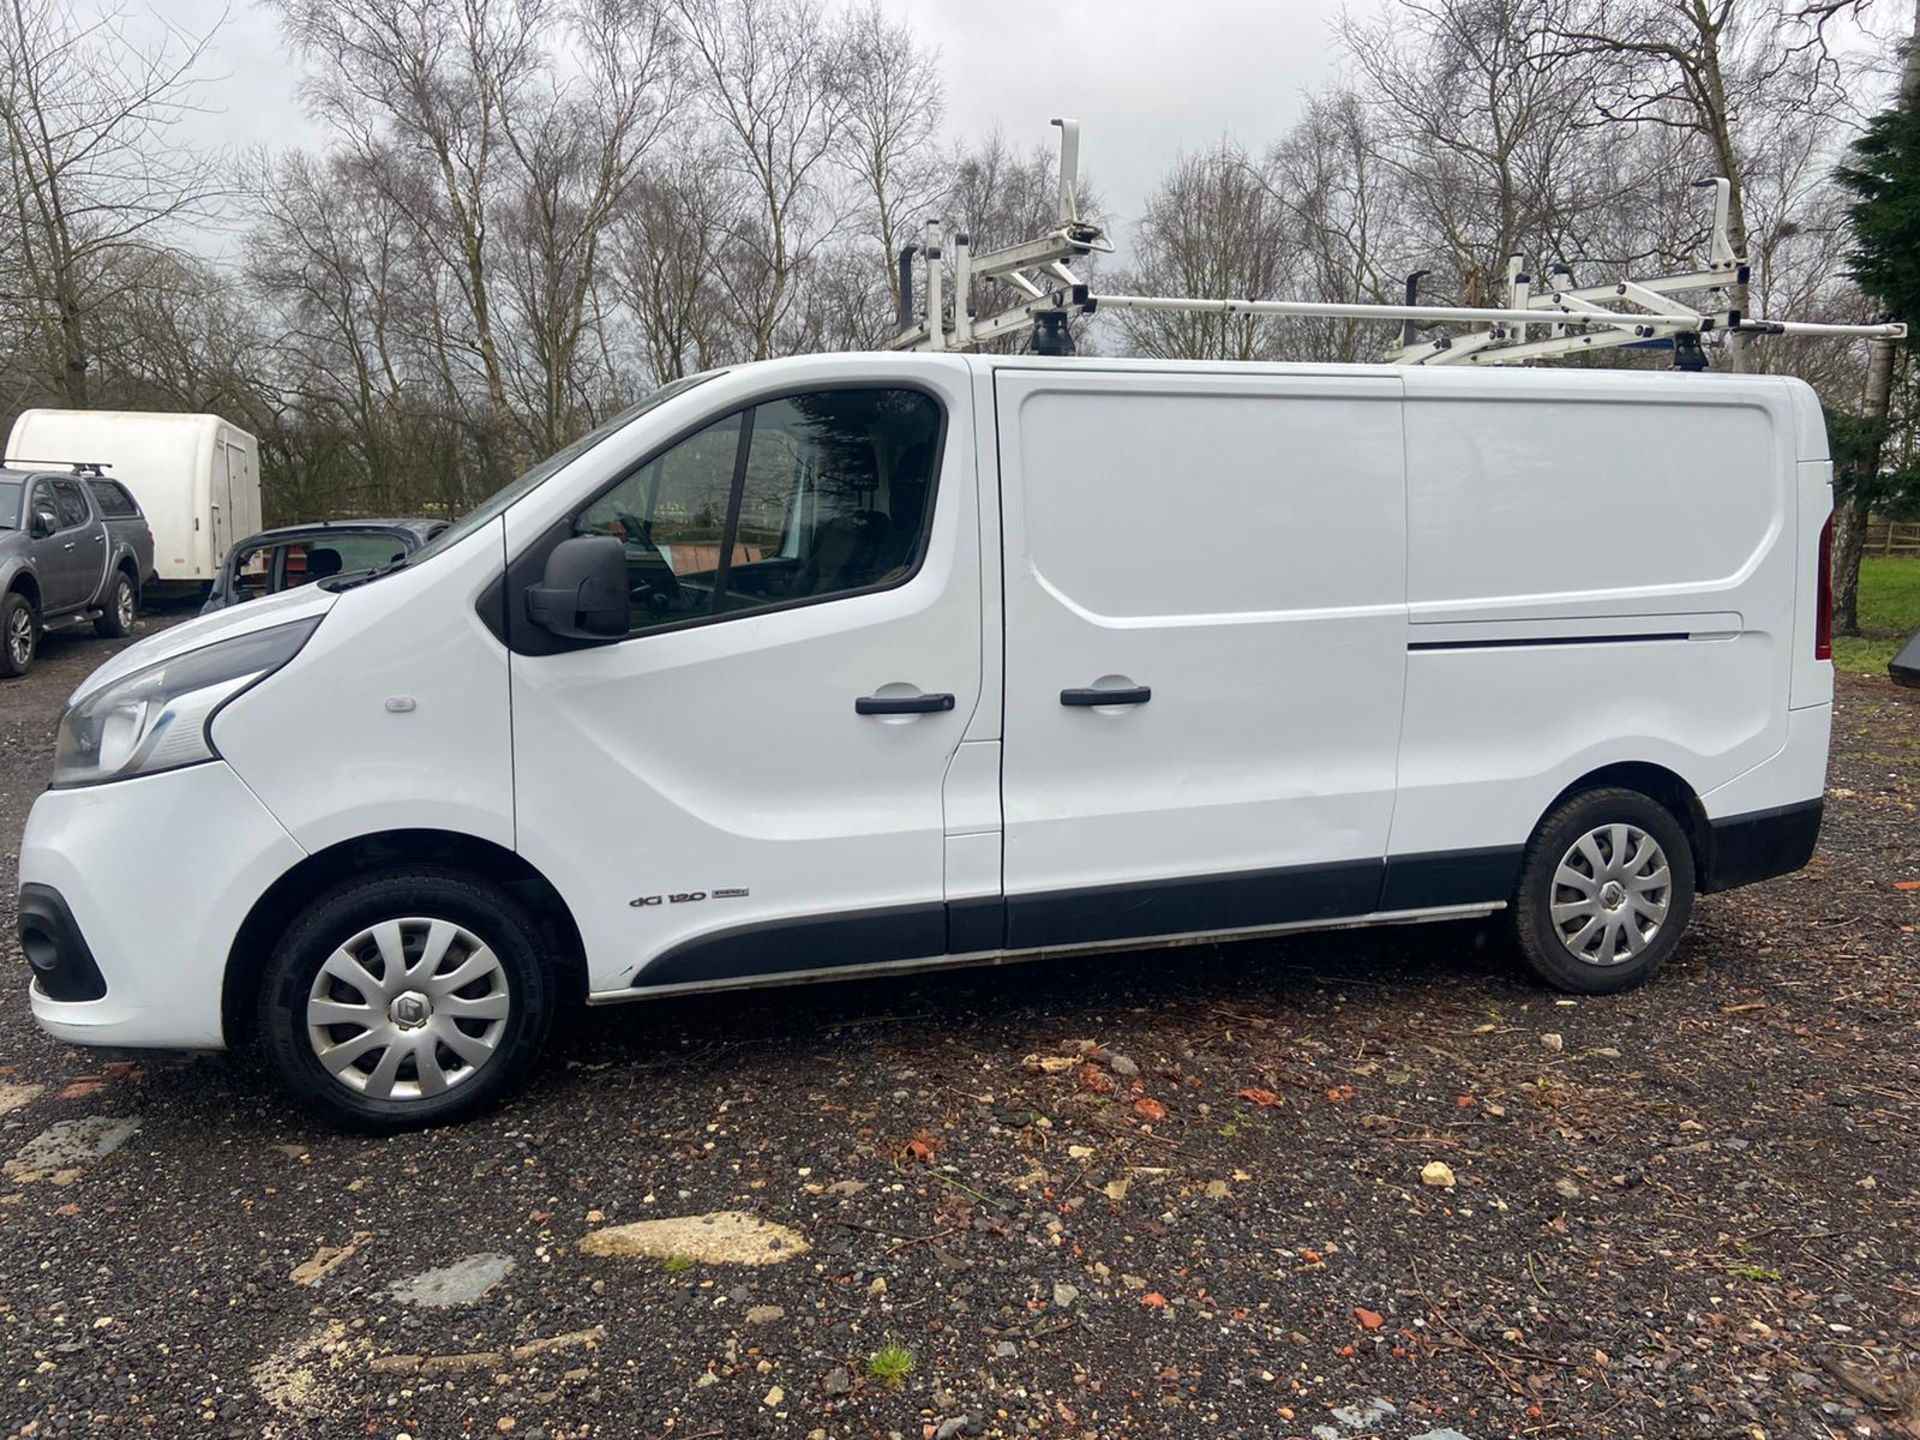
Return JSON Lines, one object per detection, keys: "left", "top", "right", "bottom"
{"left": 19, "top": 760, "right": 305, "bottom": 1050}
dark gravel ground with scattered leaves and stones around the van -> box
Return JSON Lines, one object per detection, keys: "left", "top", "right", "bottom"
{"left": 0, "top": 622, "right": 1920, "bottom": 1440}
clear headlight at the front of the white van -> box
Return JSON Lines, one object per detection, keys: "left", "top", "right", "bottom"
{"left": 54, "top": 616, "right": 321, "bottom": 787}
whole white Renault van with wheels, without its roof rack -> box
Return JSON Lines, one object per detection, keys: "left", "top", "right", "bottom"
{"left": 19, "top": 355, "right": 1832, "bottom": 1129}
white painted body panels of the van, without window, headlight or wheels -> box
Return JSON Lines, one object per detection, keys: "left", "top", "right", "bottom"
{"left": 19, "top": 355, "right": 1832, "bottom": 1046}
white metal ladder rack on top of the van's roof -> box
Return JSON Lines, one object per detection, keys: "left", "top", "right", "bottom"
{"left": 891, "top": 119, "right": 1907, "bottom": 371}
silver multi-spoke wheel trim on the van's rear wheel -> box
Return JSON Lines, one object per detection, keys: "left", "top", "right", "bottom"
{"left": 1548, "top": 824, "right": 1672, "bottom": 968}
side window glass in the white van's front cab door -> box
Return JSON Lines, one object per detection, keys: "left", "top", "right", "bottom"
{"left": 574, "top": 386, "right": 941, "bottom": 634}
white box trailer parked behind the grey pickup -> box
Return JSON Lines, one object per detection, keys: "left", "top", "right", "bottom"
{"left": 6, "top": 409, "right": 259, "bottom": 586}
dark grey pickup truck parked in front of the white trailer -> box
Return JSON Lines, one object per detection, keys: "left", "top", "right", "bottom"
{"left": 0, "top": 461, "right": 154, "bottom": 676}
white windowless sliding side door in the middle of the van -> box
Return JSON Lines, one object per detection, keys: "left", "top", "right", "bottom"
{"left": 996, "top": 367, "right": 1407, "bottom": 948}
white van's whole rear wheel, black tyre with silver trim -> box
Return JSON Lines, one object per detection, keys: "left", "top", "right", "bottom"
{"left": 1513, "top": 789, "right": 1693, "bottom": 995}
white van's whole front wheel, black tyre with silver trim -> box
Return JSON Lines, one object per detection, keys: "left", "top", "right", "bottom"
{"left": 259, "top": 870, "right": 553, "bottom": 1133}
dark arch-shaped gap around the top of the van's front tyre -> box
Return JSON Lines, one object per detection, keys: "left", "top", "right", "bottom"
{"left": 221, "top": 829, "right": 588, "bottom": 1048}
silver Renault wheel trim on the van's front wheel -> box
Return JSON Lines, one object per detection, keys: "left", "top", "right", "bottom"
{"left": 305, "top": 916, "right": 513, "bottom": 1100}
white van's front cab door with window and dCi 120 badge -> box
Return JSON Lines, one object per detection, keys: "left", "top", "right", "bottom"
{"left": 507, "top": 372, "right": 983, "bottom": 995}
